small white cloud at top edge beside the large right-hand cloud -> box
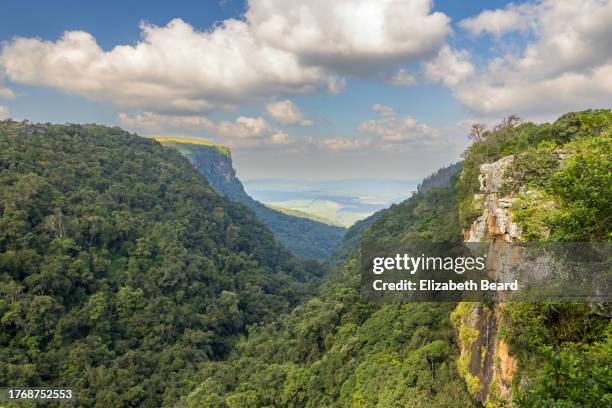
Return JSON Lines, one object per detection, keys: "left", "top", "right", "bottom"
{"left": 459, "top": 3, "right": 537, "bottom": 37}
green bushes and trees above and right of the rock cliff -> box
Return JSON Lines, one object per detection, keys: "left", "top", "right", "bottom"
{"left": 459, "top": 110, "right": 612, "bottom": 407}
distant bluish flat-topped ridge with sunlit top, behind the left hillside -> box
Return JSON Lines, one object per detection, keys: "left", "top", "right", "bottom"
{"left": 157, "top": 137, "right": 345, "bottom": 260}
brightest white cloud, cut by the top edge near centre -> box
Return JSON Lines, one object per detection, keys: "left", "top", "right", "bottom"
{"left": 246, "top": 0, "right": 450, "bottom": 75}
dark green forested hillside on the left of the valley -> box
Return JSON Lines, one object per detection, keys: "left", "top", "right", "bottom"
{"left": 0, "top": 121, "right": 310, "bottom": 407}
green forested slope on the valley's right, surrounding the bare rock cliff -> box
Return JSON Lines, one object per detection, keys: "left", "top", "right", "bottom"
{"left": 183, "top": 111, "right": 612, "bottom": 408}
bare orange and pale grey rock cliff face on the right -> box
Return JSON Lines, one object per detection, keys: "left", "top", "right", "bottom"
{"left": 453, "top": 156, "right": 522, "bottom": 406}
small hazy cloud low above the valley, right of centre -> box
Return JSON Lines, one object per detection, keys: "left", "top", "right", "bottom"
{"left": 357, "top": 104, "right": 441, "bottom": 146}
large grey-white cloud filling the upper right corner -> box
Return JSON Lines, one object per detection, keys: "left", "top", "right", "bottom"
{"left": 453, "top": 0, "right": 612, "bottom": 115}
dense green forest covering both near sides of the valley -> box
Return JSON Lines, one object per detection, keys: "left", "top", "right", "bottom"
{"left": 0, "top": 110, "right": 612, "bottom": 408}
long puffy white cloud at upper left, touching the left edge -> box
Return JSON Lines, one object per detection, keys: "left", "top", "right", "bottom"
{"left": 0, "top": 19, "right": 325, "bottom": 112}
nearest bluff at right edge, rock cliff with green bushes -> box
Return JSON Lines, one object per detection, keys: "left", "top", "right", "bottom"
{"left": 455, "top": 109, "right": 612, "bottom": 407}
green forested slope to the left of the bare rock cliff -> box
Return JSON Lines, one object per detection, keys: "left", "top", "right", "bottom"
{"left": 184, "top": 182, "right": 473, "bottom": 407}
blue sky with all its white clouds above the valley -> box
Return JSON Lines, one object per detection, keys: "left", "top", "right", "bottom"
{"left": 0, "top": 0, "right": 612, "bottom": 180}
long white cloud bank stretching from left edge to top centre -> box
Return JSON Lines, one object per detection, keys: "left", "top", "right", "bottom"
{"left": 0, "top": 0, "right": 450, "bottom": 114}
